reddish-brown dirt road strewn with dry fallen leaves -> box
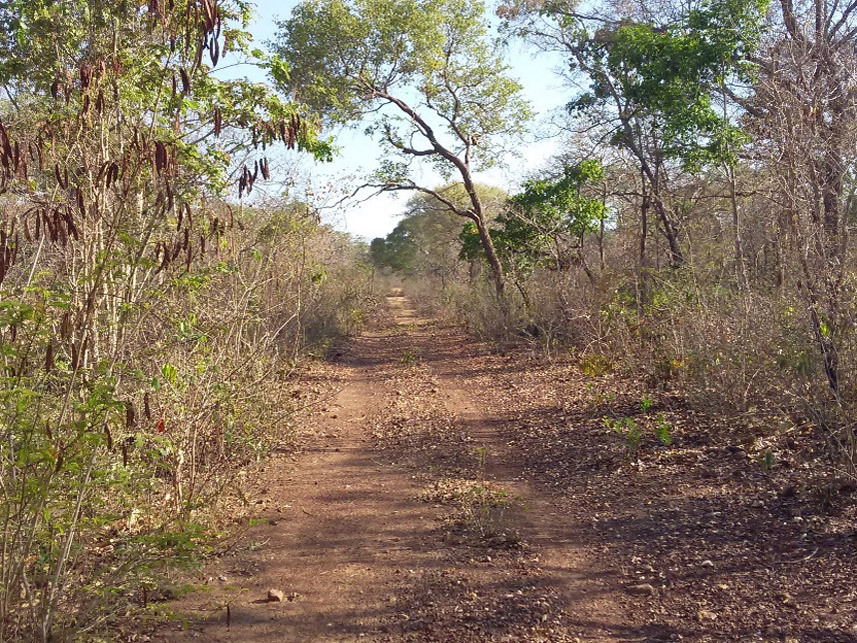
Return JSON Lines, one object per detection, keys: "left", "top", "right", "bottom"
{"left": 157, "top": 294, "right": 857, "bottom": 643}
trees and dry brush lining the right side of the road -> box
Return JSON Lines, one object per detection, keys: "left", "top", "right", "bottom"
{"left": 372, "top": 0, "right": 857, "bottom": 486}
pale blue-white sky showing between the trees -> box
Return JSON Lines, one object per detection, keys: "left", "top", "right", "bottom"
{"left": 231, "top": 0, "right": 569, "bottom": 241}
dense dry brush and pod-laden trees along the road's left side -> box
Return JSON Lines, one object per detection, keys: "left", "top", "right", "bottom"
{"left": 0, "top": 0, "right": 371, "bottom": 641}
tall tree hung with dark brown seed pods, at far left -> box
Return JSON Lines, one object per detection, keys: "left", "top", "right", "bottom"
{"left": 0, "top": 0, "right": 330, "bottom": 641}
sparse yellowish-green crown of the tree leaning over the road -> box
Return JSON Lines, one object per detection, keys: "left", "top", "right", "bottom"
{"left": 277, "top": 0, "right": 528, "bottom": 171}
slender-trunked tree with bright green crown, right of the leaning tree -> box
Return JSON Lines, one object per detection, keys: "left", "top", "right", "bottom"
{"left": 500, "top": 0, "right": 767, "bottom": 266}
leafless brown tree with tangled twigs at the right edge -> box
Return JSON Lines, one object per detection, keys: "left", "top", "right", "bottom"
{"left": 737, "top": 0, "right": 857, "bottom": 403}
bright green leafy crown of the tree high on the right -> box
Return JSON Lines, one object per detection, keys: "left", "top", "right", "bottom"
{"left": 569, "top": 0, "right": 769, "bottom": 170}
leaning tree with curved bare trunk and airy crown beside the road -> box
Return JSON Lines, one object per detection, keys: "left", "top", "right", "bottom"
{"left": 277, "top": 0, "right": 529, "bottom": 295}
